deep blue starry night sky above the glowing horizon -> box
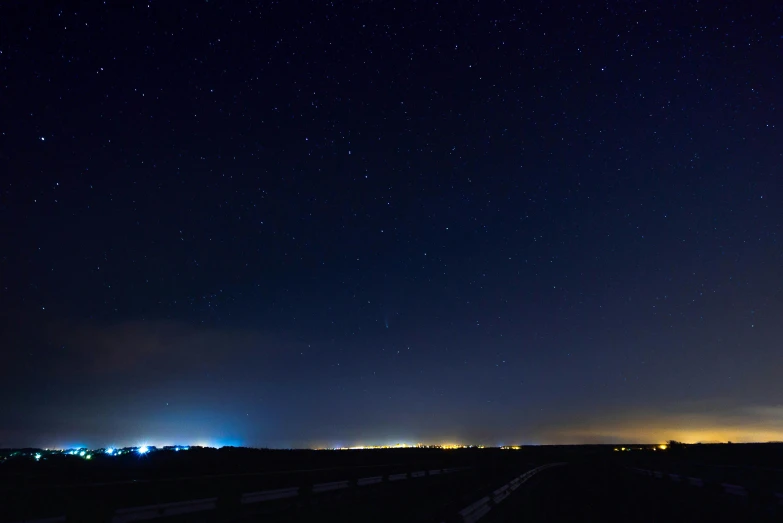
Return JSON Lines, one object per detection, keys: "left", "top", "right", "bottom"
{"left": 0, "top": 0, "right": 783, "bottom": 447}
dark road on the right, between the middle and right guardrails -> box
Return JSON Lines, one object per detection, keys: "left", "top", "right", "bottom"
{"left": 481, "top": 463, "right": 781, "bottom": 523}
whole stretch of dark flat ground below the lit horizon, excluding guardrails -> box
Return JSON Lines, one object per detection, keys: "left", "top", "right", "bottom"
{"left": 0, "top": 444, "right": 783, "bottom": 523}
